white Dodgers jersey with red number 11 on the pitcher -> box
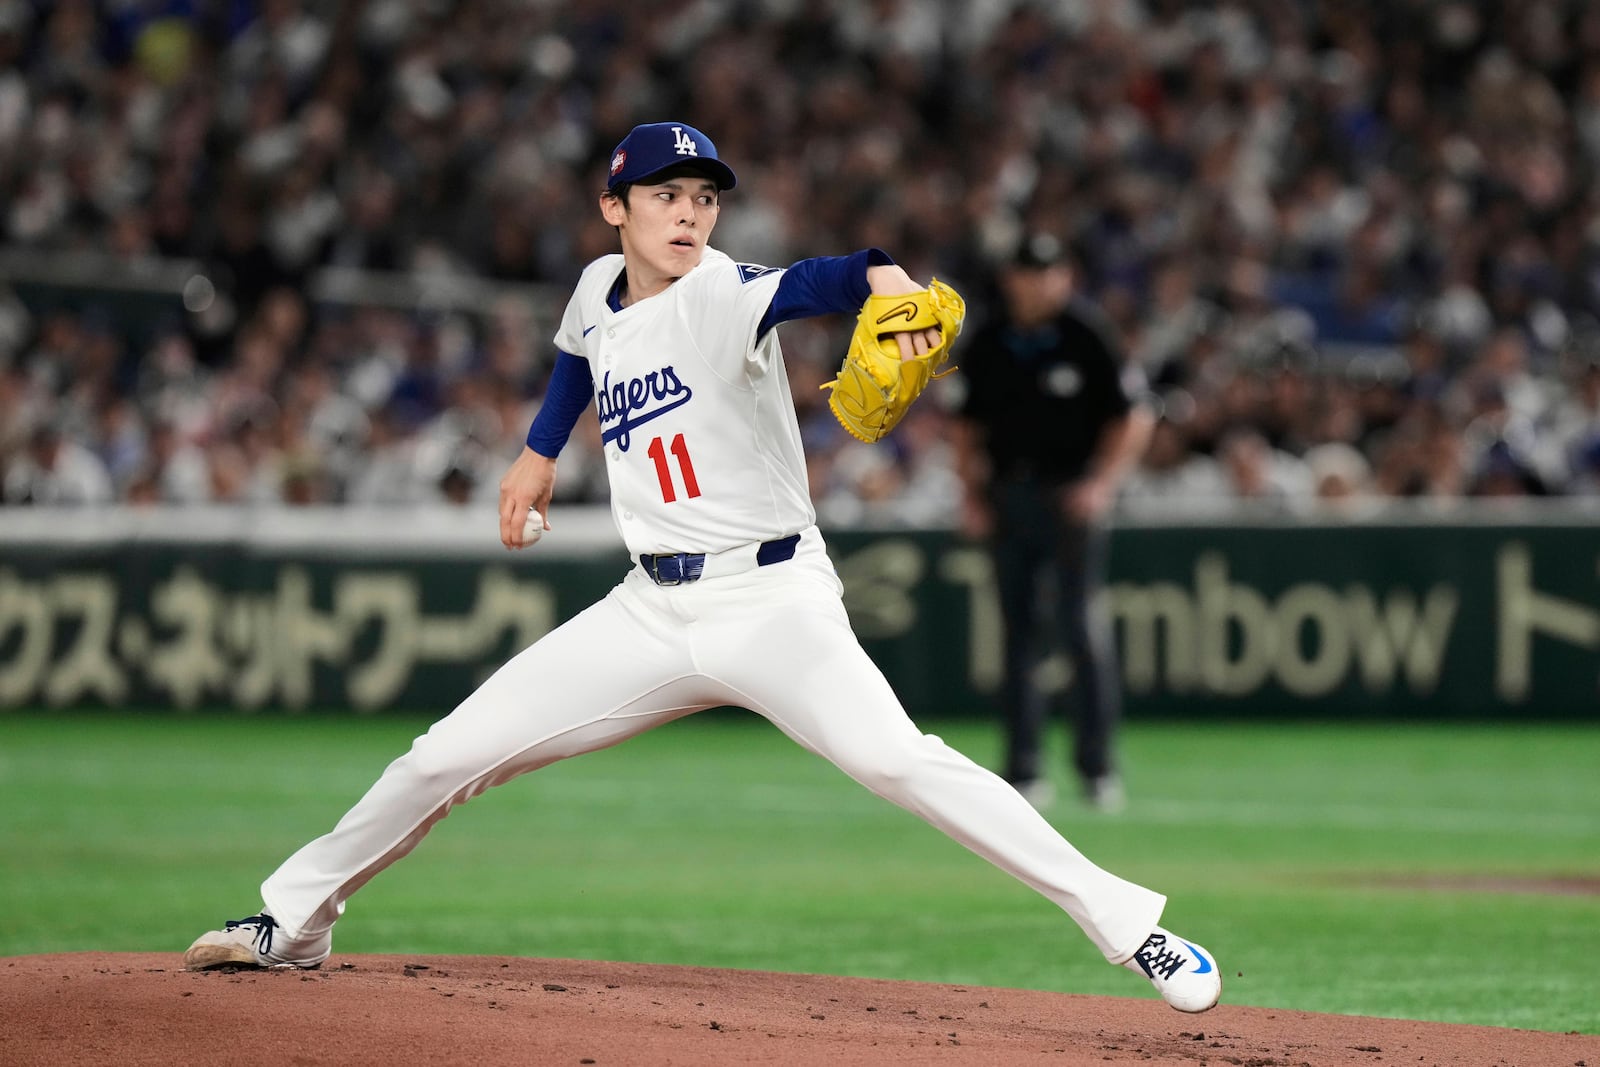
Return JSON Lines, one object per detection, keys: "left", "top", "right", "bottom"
{"left": 555, "top": 248, "right": 816, "bottom": 557}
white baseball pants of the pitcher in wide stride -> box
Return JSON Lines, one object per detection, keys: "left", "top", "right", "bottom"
{"left": 261, "top": 530, "right": 1166, "bottom": 963}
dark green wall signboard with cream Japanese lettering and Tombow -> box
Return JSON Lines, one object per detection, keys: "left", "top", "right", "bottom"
{"left": 0, "top": 523, "right": 1600, "bottom": 718}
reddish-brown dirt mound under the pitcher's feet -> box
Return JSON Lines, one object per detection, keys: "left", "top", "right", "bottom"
{"left": 0, "top": 953, "right": 1600, "bottom": 1067}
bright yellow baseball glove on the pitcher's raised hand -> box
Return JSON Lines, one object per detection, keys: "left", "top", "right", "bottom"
{"left": 822, "top": 278, "right": 966, "bottom": 445}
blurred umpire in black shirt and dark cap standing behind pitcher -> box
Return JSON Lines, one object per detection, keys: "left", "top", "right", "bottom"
{"left": 958, "top": 234, "right": 1154, "bottom": 811}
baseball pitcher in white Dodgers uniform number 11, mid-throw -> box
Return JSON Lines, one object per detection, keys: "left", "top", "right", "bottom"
{"left": 184, "top": 122, "right": 1221, "bottom": 1011}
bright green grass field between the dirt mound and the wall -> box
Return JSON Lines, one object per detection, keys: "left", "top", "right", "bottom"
{"left": 0, "top": 713, "right": 1600, "bottom": 1033}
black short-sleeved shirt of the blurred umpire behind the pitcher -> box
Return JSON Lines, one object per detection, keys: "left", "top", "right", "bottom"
{"left": 960, "top": 301, "right": 1133, "bottom": 483}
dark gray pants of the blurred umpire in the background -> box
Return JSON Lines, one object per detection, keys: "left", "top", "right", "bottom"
{"left": 992, "top": 478, "right": 1122, "bottom": 782}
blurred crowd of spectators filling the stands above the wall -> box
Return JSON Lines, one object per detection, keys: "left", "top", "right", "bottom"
{"left": 0, "top": 0, "right": 1600, "bottom": 525}
